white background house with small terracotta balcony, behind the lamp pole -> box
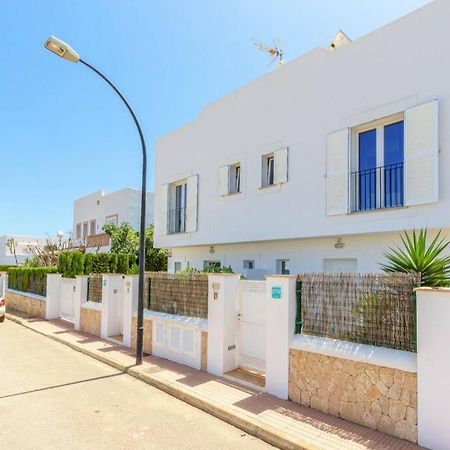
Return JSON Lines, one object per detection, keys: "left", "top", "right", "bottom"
{"left": 73, "top": 188, "right": 153, "bottom": 251}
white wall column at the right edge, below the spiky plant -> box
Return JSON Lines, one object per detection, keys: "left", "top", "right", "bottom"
{"left": 416, "top": 288, "right": 450, "bottom": 450}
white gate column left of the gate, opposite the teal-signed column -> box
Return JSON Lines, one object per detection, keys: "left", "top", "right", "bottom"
{"left": 207, "top": 274, "right": 240, "bottom": 375}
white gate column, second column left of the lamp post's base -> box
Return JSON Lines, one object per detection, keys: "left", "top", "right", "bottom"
{"left": 100, "top": 274, "right": 123, "bottom": 339}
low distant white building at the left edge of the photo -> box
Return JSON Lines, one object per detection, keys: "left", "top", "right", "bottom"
{"left": 0, "top": 234, "right": 48, "bottom": 266}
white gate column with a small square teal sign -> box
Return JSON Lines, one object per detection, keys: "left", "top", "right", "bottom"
{"left": 266, "top": 275, "right": 297, "bottom": 399}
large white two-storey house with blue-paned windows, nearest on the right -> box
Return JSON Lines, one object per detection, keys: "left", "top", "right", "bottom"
{"left": 155, "top": 0, "right": 450, "bottom": 278}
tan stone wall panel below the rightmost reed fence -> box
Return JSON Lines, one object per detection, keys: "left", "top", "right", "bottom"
{"left": 289, "top": 349, "right": 417, "bottom": 442}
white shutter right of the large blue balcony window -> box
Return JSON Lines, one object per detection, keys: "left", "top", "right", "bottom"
{"left": 405, "top": 100, "right": 439, "bottom": 206}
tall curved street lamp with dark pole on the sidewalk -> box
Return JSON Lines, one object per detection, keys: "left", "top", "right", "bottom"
{"left": 44, "top": 36, "right": 147, "bottom": 365}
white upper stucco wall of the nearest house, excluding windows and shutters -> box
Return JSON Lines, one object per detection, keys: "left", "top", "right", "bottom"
{"left": 155, "top": 0, "right": 450, "bottom": 253}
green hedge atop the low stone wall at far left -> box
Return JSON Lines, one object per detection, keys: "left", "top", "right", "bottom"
{"left": 8, "top": 267, "right": 57, "bottom": 297}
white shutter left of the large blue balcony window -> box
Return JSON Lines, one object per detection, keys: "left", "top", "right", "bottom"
{"left": 327, "top": 128, "right": 349, "bottom": 216}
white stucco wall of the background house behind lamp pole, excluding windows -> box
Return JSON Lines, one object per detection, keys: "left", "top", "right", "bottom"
{"left": 73, "top": 188, "right": 153, "bottom": 239}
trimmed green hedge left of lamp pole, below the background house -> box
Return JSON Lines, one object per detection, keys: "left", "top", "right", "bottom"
{"left": 58, "top": 251, "right": 135, "bottom": 278}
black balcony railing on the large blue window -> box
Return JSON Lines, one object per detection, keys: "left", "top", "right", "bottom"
{"left": 351, "top": 163, "right": 404, "bottom": 211}
